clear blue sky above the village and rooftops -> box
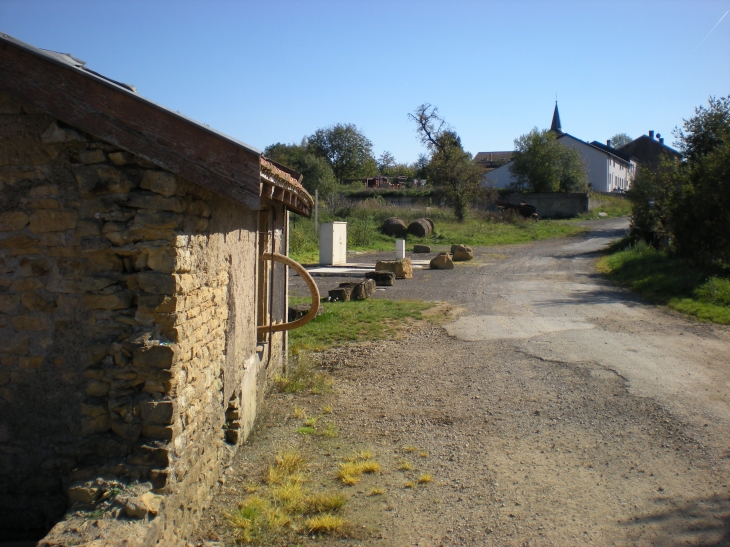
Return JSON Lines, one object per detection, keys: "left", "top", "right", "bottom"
{"left": 0, "top": 0, "right": 730, "bottom": 162}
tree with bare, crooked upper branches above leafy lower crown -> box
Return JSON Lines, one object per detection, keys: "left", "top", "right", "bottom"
{"left": 408, "top": 103, "right": 484, "bottom": 222}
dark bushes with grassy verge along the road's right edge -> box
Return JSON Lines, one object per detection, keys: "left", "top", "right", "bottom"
{"left": 598, "top": 97, "right": 730, "bottom": 324}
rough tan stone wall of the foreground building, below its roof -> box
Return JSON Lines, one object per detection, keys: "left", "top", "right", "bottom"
{"left": 0, "top": 95, "right": 287, "bottom": 545}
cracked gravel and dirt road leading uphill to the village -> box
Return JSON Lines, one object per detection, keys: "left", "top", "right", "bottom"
{"left": 191, "top": 221, "right": 730, "bottom": 546}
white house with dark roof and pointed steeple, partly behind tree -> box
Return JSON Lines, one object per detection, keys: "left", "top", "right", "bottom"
{"left": 482, "top": 102, "right": 637, "bottom": 192}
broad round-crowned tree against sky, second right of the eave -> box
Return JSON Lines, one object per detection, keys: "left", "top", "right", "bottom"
{"left": 309, "top": 124, "right": 377, "bottom": 184}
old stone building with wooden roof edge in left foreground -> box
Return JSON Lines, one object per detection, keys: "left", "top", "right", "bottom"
{"left": 0, "top": 35, "right": 312, "bottom": 545}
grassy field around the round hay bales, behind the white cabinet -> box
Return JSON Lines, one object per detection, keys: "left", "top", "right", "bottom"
{"left": 289, "top": 204, "right": 584, "bottom": 264}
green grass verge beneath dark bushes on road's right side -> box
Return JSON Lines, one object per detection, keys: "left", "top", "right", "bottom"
{"left": 597, "top": 240, "right": 730, "bottom": 325}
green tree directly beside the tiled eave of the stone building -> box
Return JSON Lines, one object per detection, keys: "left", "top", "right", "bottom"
{"left": 264, "top": 139, "right": 337, "bottom": 199}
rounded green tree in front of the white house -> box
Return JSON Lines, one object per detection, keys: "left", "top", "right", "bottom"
{"left": 510, "top": 127, "right": 588, "bottom": 192}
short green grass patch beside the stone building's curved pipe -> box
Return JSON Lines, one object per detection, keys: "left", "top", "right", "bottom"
{"left": 286, "top": 298, "right": 432, "bottom": 356}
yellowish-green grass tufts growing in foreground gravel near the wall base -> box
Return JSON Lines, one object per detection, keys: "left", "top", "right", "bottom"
{"left": 226, "top": 451, "right": 347, "bottom": 545}
